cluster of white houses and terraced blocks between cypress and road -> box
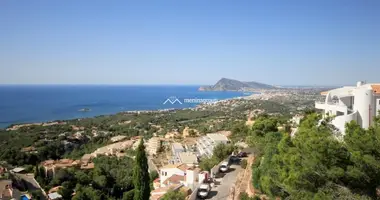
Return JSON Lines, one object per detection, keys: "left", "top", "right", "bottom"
{"left": 148, "top": 132, "right": 229, "bottom": 200}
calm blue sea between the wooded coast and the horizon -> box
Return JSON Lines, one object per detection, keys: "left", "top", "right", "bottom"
{"left": 0, "top": 85, "right": 249, "bottom": 128}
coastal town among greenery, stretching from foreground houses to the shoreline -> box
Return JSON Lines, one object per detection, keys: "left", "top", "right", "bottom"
{"left": 0, "top": 82, "right": 380, "bottom": 200}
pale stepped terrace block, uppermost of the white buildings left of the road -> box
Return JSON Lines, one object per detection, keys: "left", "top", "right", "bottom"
{"left": 197, "top": 133, "right": 229, "bottom": 157}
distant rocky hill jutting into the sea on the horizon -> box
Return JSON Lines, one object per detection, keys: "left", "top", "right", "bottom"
{"left": 199, "top": 78, "right": 276, "bottom": 91}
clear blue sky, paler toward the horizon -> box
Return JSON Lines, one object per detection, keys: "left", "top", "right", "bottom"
{"left": 0, "top": 0, "right": 380, "bottom": 85}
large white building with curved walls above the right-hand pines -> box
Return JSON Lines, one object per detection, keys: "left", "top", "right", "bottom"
{"left": 315, "top": 82, "right": 380, "bottom": 134}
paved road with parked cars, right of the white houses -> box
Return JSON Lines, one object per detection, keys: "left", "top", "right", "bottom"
{"left": 197, "top": 165, "right": 241, "bottom": 200}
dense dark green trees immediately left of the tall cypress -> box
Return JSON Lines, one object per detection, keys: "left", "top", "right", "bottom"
{"left": 35, "top": 157, "right": 136, "bottom": 199}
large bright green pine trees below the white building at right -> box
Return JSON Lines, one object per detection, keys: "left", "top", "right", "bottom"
{"left": 247, "top": 113, "right": 380, "bottom": 200}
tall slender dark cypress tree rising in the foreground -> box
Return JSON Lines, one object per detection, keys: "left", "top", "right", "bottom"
{"left": 133, "top": 139, "right": 150, "bottom": 200}
